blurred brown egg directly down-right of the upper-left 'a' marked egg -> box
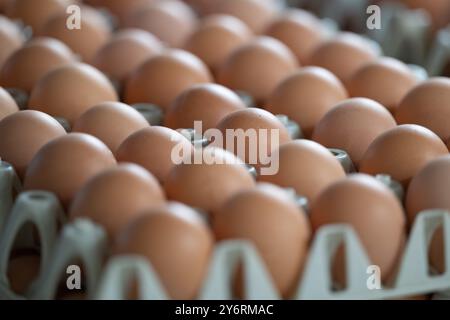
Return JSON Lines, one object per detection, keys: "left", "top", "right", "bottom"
{"left": 92, "top": 29, "right": 163, "bottom": 82}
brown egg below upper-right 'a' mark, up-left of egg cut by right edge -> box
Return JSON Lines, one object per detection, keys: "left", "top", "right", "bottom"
{"left": 347, "top": 58, "right": 418, "bottom": 113}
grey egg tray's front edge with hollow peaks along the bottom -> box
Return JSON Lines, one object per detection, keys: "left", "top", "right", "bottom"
{"left": 0, "top": 162, "right": 450, "bottom": 300}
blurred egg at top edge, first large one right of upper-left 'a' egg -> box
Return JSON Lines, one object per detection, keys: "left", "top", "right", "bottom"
{"left": 126, "top": 0, "right": 197, "bottom": 47}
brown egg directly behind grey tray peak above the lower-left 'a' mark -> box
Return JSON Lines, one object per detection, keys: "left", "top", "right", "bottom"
{"left": 69, "top": 163, "right": 165, "bottom": 239}
